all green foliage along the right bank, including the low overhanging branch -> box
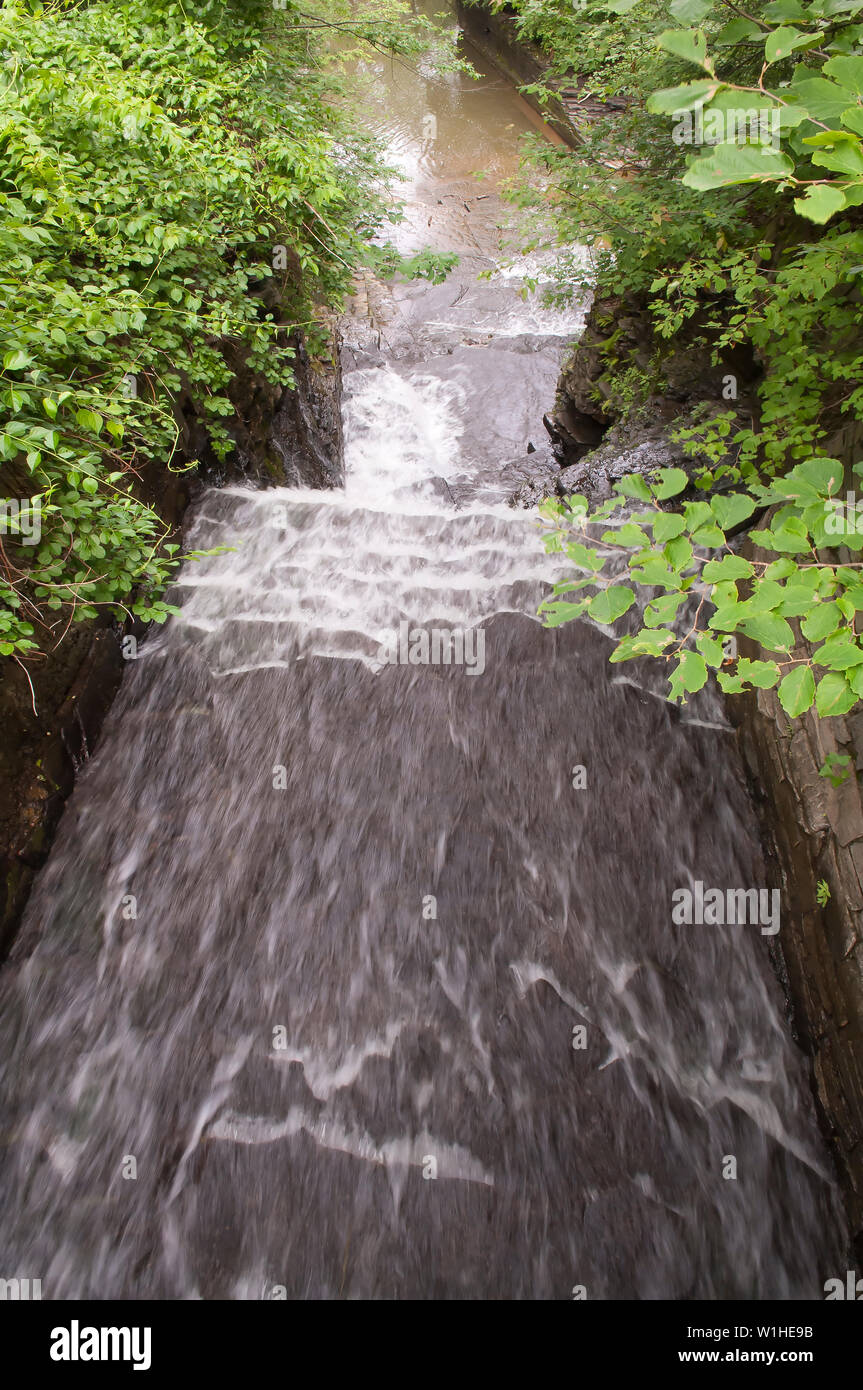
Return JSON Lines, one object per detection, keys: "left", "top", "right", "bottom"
{"left": 491, "top": 0, "right": 863, "bottom": 717}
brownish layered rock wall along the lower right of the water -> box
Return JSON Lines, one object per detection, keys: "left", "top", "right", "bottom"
{"left": 728, "top": 678, "right": 863, "bottom": 1258}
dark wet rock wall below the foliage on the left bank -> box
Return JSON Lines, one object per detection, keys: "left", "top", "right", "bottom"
{"left": 0, "top": 329, "right": 343, "bottom": 959}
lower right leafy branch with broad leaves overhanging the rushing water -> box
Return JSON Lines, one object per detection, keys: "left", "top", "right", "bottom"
{"left": 542, "top": 459, "right": 863, "bottom": 706}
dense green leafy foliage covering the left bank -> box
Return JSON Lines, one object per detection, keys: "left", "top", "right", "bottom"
{"left": 0, "top": 0, "right": 436, "bottom": 655}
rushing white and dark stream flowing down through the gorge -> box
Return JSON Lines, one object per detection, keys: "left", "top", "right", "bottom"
{"left": 0, "top": 10, "right": 845, "bottom": 1298}
